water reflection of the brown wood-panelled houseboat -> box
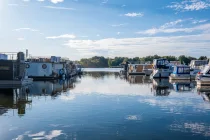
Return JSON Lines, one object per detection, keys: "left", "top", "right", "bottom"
{"left": 128, "top": 75, "right": 152, "bottom": 84}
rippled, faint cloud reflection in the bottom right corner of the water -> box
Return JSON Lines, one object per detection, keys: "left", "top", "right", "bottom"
{"left": 170, "top": 122, "right": 210, "bottom": 136}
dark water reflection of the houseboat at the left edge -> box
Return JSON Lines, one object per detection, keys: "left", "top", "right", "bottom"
{"left": 0, "top": 87, "right": 32, "bottom": 116}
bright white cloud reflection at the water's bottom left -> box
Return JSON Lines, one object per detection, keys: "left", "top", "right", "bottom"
{"left": 14, "top": 130, "right": 63, "bottom": 140}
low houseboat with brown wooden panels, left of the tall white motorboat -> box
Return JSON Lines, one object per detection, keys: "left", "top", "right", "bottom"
{"left": 128, "top": 64, "right": 152, "bottom": 76}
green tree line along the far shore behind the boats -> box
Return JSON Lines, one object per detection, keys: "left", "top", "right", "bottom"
{"left": 79, "top": 55, "right": 208, "bottom": 68}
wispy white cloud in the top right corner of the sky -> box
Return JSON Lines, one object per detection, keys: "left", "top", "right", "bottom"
{"left": 167, "top": 0, "right": 210, "bottom": 12}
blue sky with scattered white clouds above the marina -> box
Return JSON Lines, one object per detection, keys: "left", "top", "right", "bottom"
{"left": 0, "top": 0, "right": 210, "bottom": 60}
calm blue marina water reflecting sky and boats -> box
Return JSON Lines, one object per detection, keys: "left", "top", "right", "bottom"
{"left": 0, "top": 69, "right": 210, "bottom": 140}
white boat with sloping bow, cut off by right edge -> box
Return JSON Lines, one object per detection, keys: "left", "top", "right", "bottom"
{"left": 196, "top": 64, "right": 210, "bottom": 88}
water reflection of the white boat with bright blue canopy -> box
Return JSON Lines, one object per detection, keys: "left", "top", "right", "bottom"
{"left": 170, "top": 80, "right": 195, "bottom": 92}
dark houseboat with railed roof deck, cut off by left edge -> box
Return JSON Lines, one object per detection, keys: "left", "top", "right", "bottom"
{"left": 0, "top": 52, "right": 33, "bottom": 88}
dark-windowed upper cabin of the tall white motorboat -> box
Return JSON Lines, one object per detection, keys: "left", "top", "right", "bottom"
{"left": 153, "top": 58, "right": 169, "bottom": 69}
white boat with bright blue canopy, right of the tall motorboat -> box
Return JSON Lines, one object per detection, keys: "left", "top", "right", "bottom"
{"left": 169, "top": 65, "right": 191, "bottom": 80}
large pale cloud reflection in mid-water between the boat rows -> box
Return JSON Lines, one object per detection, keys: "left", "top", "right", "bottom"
{"left": 71, "top": 76, "right": 152, "bottom": 96}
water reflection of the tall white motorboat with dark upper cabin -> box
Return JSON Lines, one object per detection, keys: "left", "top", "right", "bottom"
{"left": 153, "top": 79, "right": 173, "bottom": 96}
